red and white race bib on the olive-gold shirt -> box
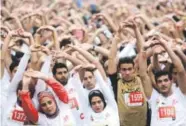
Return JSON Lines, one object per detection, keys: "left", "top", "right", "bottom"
{"left": 124, "top": 92, "right": 144, "bottom": 106}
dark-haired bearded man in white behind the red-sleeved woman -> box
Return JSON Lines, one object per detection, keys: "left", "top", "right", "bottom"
{"left": 52, "top": 63, "right": 84, "bottom": 126}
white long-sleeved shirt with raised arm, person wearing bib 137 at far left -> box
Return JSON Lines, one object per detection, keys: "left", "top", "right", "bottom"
{"left": 2, "top": 53, "right": 30, "bottom": 126}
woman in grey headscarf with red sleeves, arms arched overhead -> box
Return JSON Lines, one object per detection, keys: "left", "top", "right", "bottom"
{"left": 20, "top": 71, "right": 76, "bottom": 126}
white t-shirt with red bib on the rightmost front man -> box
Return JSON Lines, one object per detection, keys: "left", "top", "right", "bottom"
{"left": 148, "top": 88, "right": 186, "bottom": 126}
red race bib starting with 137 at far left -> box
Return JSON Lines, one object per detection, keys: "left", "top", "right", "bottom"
{"left": 12, "top": 110, "right": 26, "bottom": 122}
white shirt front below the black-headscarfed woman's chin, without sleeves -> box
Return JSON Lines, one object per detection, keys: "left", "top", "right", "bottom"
{"left": 89, "top": 106, "right": 119, "bottom": 126}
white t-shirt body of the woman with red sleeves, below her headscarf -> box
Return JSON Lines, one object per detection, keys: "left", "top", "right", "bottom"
{"left": 38, "top": 104, "right": 76, "bottom": 126}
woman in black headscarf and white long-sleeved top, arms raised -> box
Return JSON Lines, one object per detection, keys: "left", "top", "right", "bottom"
{"left": 74, "top": 65, "right": 120, "bottom": 126}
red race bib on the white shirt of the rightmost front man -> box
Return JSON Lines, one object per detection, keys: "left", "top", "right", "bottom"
{"left": 158, "top": 106, "right": 176, "bottom": 119}
